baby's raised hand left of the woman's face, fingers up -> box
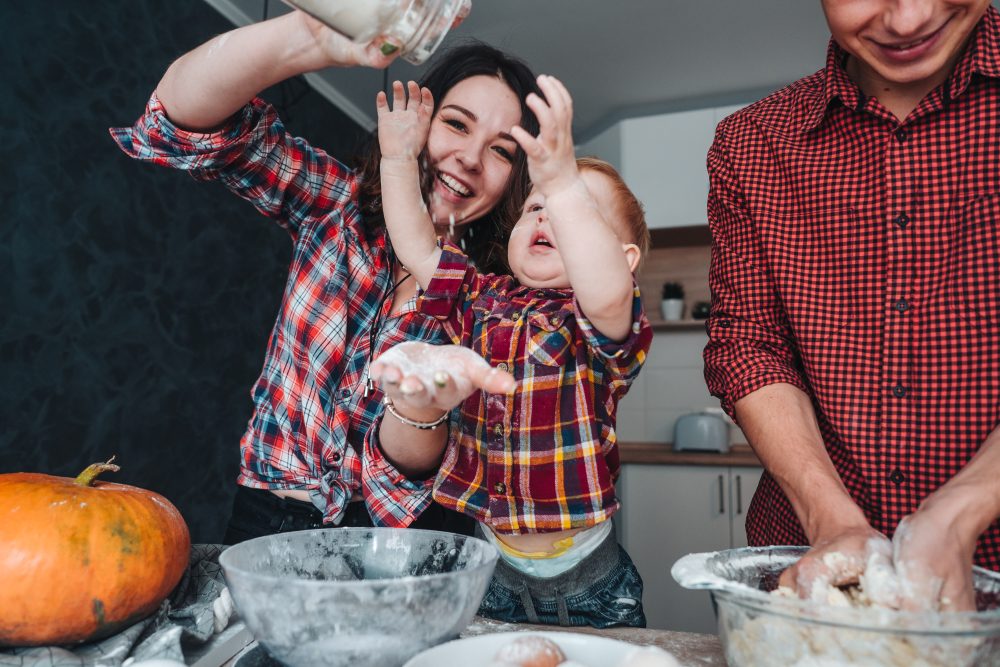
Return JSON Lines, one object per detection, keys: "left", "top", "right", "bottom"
{"left": 375, "top": 81, "right": 434, "bottom": 160}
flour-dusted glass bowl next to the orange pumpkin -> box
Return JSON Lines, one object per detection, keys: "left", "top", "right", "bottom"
{"left": 219, "top": 528, "right": 498, "bottom": 667}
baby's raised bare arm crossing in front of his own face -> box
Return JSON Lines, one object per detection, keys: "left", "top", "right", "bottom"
{"left": 511, "top": 74, "right": 633, "bottom": 340}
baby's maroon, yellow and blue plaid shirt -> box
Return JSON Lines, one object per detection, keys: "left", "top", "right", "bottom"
{"left": 418, "top": 244, "right": 652, "bottom": 533}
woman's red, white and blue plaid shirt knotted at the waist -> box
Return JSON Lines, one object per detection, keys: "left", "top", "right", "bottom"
{"left": 111, "top": 95, "right": 447, "bottom": 526}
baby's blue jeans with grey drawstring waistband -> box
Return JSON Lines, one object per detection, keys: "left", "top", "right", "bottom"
{"left": 479, "top": 532, "right": 646, "bottom": 628}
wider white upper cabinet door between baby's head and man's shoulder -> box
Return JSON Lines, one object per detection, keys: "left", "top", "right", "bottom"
{"left": 621, "top": 108, "right": 715, "bottom": 229}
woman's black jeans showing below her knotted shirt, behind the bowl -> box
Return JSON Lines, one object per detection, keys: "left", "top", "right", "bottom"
{"left": 223, "top": 486, "right": 476, "bottom": 544}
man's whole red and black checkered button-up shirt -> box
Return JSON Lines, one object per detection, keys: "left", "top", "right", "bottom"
{"left": 705, "top": 7, "right": 1000, "bottom": 570}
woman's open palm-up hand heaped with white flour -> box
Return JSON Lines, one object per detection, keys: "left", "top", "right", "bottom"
{"left": 371, "top": 341, "right": 516, "bottom": 418}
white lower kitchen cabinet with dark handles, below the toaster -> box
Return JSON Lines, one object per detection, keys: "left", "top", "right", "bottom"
{"left": 617, "top": 464, "right": 763, "bottom": 633}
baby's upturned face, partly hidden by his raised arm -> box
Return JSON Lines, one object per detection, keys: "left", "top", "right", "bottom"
{"left": 507, "top": 169, "right": 621, "bottom": 289}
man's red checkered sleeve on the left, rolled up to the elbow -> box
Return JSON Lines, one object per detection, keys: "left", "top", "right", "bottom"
{"left": 704, "top": 117, "right": 808, "bottom": 418}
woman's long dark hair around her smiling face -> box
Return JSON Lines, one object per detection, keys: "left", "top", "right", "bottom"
{"left": 358, "top": 41, "right": 542, "bottom": 273}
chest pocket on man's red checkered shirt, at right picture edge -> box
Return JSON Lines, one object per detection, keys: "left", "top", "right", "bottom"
{"left": 947, "top": 193, "right": 1000, "bottom": 324}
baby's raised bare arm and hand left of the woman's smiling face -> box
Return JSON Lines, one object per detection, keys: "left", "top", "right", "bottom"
{"left": 375, "top": 81, "right": 441, "bottom": 288}
